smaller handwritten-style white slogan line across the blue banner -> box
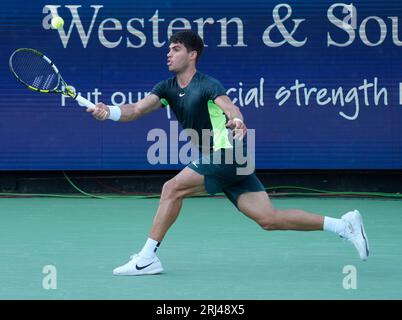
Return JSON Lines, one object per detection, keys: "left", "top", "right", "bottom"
{"left": 61, "top": 77, "right": 402, "bottom": 120}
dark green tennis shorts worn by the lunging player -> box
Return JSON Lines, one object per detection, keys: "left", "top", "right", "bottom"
{"left": 188, "top": 149, "right": 265, "bottom": 209}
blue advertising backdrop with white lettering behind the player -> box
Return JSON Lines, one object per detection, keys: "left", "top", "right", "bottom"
{"left": 0, "top": 0, "right": 402, "bottom": 170}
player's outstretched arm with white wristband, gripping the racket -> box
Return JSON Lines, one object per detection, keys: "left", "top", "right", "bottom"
{"left": 87, "top": 94, "right": 161, "bottom": 122}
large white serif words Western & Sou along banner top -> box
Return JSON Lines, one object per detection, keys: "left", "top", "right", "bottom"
{"left": 42, "top": 3, "right": 402, "bottom": 49}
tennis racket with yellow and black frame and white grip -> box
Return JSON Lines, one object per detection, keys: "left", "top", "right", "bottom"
{"left": 9, "top": 48, "right": 95, "bottom": 109}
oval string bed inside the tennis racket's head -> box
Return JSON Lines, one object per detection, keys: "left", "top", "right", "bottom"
{"left": 11, "top": 50, "right": 59, "bottom": 90}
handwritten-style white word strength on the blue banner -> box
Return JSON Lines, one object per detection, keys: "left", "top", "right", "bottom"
{"left": 275, "top": 77, "right": 388, "bottom": 120}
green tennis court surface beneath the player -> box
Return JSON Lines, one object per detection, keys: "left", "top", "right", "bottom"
{"left": 0, "top": 198, "right": 402, "bottom": 300}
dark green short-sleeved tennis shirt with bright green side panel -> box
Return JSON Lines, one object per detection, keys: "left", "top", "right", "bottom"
{"left": 151, "top": 71, "right": 232, "bottom": 151}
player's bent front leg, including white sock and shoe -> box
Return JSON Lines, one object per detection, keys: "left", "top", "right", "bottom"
{"left": 113, "top": 167, "right": 205, "bottom": 275}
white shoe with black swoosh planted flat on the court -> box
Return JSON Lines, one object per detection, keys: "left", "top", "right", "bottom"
{"left": 113, "top": 254, "right": 163, "bottom": 276}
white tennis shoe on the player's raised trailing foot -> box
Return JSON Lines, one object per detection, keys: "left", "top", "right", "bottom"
{"left": 340, "top": 210, "right": 369, "bottom": 261}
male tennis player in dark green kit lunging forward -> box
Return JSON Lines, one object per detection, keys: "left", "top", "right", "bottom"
{"left": 87, "top": 30, "right": 369, "bottom": 275}
